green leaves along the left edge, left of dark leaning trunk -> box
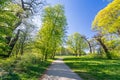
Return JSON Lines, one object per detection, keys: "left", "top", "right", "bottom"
{"left": 0, "top": 0, "right": 23, "bottom": 54}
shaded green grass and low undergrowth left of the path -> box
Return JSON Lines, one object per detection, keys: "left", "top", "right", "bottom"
{"left": 0, "top": 54, "right": 53, "bottom": 80}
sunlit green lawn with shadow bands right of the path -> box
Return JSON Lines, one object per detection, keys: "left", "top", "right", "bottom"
{"left": 64, "top": 56, "right": 120, "bottom": 80}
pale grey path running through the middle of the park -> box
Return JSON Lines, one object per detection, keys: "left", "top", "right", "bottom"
{"left": 42, "top": 59, "right": 82, "bottom": 80}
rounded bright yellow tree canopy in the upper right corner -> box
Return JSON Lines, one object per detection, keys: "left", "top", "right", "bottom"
{"left": 92, "top": 0, "right": 120, "bottom": 35}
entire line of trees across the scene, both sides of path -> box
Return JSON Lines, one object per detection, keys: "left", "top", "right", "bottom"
{"left": 0, "top": 0, "right": 120, "bottom": 60}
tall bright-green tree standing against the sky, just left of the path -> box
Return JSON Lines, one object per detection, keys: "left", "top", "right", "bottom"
{"left": 36, "top": 4, "right": 67, "bottom": 60}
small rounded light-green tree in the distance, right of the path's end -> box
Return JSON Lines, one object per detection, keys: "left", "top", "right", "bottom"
{"left": 67, "top": 33, "right": 86, "bottom": 56}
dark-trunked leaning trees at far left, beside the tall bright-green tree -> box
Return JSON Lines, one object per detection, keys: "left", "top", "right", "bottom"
{"left": 0, "top": 0, "right": 45, "bottom": 57}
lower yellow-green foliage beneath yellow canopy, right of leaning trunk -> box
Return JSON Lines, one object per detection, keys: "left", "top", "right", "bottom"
{"left": 102, "top": 34, "right": 120, "bottom": 59}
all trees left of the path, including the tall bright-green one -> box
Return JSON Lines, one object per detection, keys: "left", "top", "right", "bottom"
{"left": 0, "top": 0, "right": 67, "bottom": 60}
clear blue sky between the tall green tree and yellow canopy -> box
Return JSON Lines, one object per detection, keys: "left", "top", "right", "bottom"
{"left": 47, "top": 0, "right": 110, "bottom": 38}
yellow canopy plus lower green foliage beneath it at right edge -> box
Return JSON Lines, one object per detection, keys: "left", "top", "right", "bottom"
{"left": 92, "top": 0, "right": 120, "bottom": 58}
